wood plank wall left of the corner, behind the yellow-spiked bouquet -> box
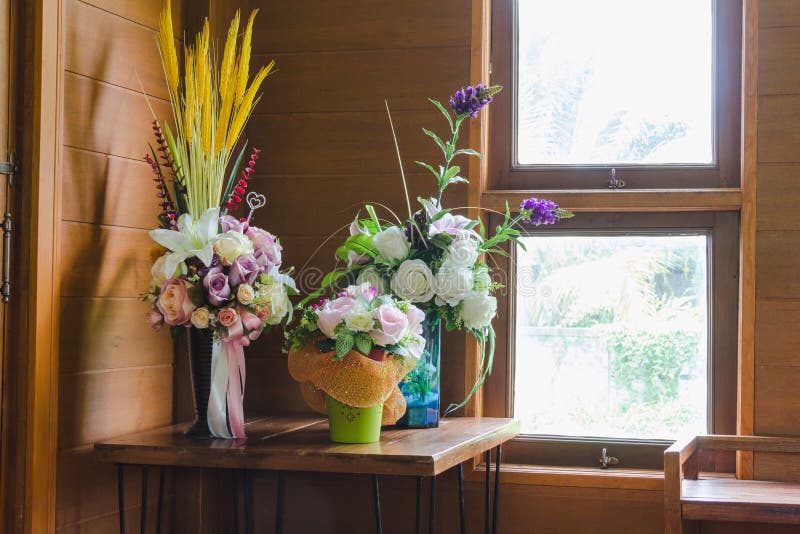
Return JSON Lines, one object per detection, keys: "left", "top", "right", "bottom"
{"left": 56, "top": 0, "right": 182, "bottom": 533}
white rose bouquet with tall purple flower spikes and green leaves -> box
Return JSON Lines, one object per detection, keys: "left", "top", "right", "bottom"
{"left": 304, "top": 84, "right": 572, "bottom": 413}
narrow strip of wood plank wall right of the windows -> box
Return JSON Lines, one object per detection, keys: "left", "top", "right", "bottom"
{"left": 754, "top": 0, "right": 800, "bottom": 481}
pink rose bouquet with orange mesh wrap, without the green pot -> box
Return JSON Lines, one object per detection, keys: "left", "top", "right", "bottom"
{"left": 286, "top": 283, "right": 425, "bottom": 432}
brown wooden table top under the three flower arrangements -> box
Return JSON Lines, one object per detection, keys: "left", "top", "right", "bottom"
{"left": 94, "top": 417, "right": 520, "bottom": 476}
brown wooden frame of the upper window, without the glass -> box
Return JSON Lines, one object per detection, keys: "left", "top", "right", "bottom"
{"left": 488, "top": 0, "right": 743, "bottom": 190}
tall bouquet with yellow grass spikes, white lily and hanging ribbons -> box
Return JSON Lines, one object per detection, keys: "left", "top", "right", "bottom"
{"left": 143, "top": 0, "right": 297, "bottom": 438}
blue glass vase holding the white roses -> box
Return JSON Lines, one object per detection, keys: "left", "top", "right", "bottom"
{"left": 397, "top": 313, "right": 442, "bottom": 428}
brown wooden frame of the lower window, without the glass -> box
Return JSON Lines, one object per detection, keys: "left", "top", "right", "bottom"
{"left": 483, "top": 212, "right": 739, "bottom": 470}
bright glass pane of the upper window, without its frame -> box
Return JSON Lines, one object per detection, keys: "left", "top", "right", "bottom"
{"left": 516, "top": 0, "right": 714, "bottom": 165}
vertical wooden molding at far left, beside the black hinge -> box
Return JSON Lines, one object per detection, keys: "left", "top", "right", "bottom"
{"left": 20, "top": 0, "right": 64, "bottom": 533}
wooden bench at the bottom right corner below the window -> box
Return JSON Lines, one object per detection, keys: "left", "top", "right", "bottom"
{"left": 664, "top": 436, "right": 800, "bottom": 534}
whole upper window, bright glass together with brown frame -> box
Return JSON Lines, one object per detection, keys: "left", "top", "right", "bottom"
{"left": 489, "top": 0, "right": 742, "bottom": 189}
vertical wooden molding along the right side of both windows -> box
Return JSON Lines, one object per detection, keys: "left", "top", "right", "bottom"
{"left": 736, "top": 0, "right": 759, "bottom": 479}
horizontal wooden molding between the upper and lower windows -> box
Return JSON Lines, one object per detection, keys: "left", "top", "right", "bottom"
{"left": 481, "top": 188, "right": 742, "bottom": 213}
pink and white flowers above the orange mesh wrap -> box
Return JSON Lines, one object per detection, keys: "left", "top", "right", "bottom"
{"left": 286, "top": 283, "right": 425, "bottom": 360}
